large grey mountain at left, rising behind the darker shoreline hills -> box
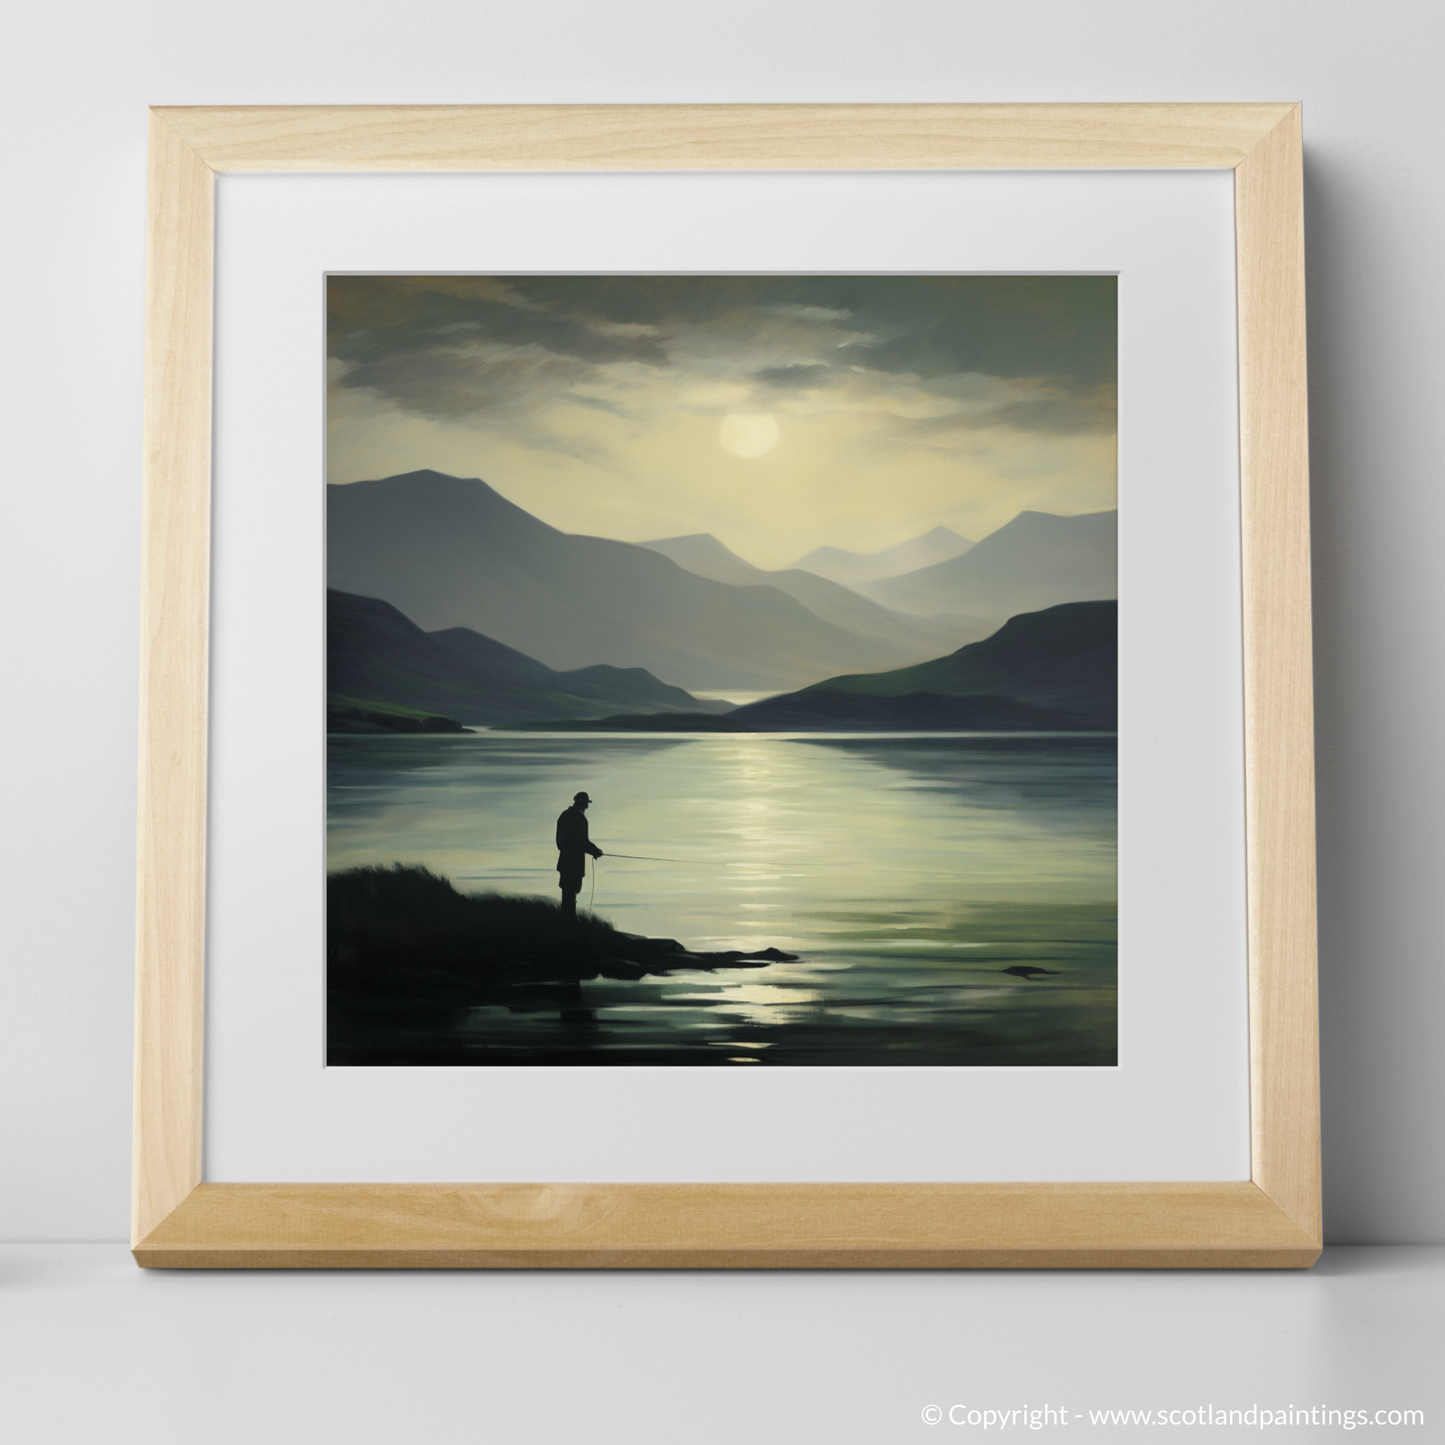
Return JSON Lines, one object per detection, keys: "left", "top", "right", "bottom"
{"left": 327, "top": 471, "right": 953, "bottom": 689}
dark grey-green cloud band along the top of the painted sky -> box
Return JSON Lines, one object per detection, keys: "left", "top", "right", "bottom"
{"left": 329, "top": 276, "right": 1117, "bottom": 434}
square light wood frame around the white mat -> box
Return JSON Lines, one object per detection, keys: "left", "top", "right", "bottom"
{"left": 133, "top": 104, "right": 1321, "bottom": 1269}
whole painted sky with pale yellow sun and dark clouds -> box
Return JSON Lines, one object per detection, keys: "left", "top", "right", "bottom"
{"left": 328, "top": 276, "right": 1117, "bottom": 568}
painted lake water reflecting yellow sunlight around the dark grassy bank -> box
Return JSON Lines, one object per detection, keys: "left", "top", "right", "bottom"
{"left": 329, "top": 733, "right": 1116, "bottom": 1066}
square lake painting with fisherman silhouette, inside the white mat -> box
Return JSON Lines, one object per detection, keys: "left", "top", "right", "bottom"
{"left": 325, "top": 275, "right": 1118, "bottom": 1068}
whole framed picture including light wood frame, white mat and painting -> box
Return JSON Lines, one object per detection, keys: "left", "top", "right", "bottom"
{"left": 134, "top": 105, "right": 1319, "bottom": 1267}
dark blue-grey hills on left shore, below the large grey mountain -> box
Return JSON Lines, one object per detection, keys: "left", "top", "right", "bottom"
{"left": 327, "top": 591, "right": 727, "bottom": 731}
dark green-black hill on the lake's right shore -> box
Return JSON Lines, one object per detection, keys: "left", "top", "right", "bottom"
{"left": 728, "top": 601, "right": 1118, "bottom": 730}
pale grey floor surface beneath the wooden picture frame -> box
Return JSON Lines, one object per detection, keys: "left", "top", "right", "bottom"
{"left": 0, "top": 1244, "right": 1445, "bottom": 1445}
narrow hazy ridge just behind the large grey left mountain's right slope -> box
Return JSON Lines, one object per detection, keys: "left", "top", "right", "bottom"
{"left": 639, "top": 532, "right": 993, "bottom": 659}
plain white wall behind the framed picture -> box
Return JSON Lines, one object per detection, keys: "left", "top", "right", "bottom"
{"left": 0, "top": 0, "right": 1445, "bottom": 1243}
